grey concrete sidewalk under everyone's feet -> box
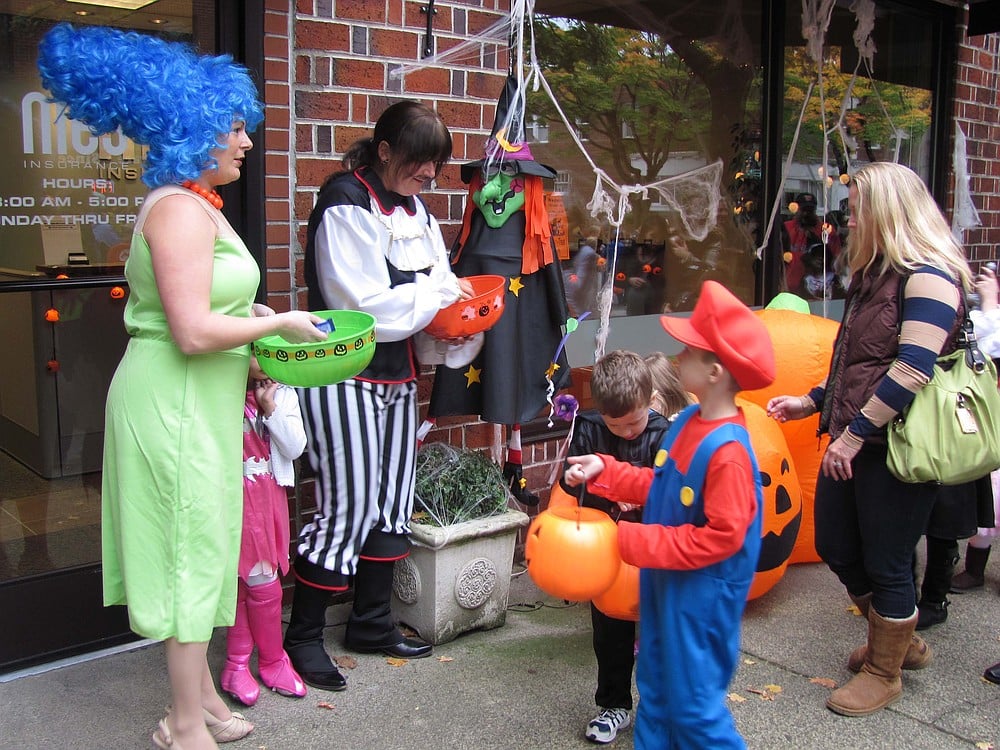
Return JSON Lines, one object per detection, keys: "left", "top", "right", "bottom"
{"left": 0, "top": 555, "right": 1000, "bottom": 750}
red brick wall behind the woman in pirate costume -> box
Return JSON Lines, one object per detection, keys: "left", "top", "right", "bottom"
{"left": 264, "top": 0, "right": 568, "bottom": 516}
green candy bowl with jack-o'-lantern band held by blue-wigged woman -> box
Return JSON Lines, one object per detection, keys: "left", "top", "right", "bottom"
{"left": 253, "top": 310, "right": 375, "bottom": 388}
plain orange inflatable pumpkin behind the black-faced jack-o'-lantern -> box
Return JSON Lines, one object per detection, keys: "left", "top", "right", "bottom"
{"left": 740, "top": 309, "right": 839, "bottom": 563}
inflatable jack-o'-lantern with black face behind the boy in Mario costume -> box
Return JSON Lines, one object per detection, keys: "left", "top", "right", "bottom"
{"left": 736, "top": 398, "right": 802, "bottom": 599}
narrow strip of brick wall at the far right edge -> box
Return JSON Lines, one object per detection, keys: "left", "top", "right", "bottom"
{"left": 952, "top": 15, "right": 1000, "bottom": 270}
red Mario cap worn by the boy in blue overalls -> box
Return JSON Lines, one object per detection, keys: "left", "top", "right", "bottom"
{"left": 660, "top": 281, "right": 774, "bottom": 391}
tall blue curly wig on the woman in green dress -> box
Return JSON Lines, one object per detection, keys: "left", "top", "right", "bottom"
{"left": 38, "top": 23, "right": 264, "bottom": 188}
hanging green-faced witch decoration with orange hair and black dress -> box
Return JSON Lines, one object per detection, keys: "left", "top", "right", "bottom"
{"left": 421, "top": 75, "right": 569, "bottom": 505}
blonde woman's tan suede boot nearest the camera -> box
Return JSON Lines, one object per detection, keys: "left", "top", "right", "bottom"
{"left": 826, "top": 607, "right": 917, "bottom": 716}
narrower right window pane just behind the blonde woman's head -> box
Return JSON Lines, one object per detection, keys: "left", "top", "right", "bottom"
{"left": 776, "top": 3, "right": 934, "bottom": 301}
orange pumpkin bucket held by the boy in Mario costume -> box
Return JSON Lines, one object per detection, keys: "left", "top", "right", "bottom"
{"left": 524, "top": 507, "right": 622, "bottom": 602}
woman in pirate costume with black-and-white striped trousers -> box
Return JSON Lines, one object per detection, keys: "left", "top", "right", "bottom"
{"left": 285, "top": 101, "right": 471, "bottom": 690}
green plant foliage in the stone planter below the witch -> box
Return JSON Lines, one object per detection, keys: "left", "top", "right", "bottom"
{"left": 414, "top": 443, "right": 510, "bottom": 526}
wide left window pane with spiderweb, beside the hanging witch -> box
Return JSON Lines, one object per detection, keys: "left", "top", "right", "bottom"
{"left": 528, "top": 2, "right": 762, "bottom": 316}
